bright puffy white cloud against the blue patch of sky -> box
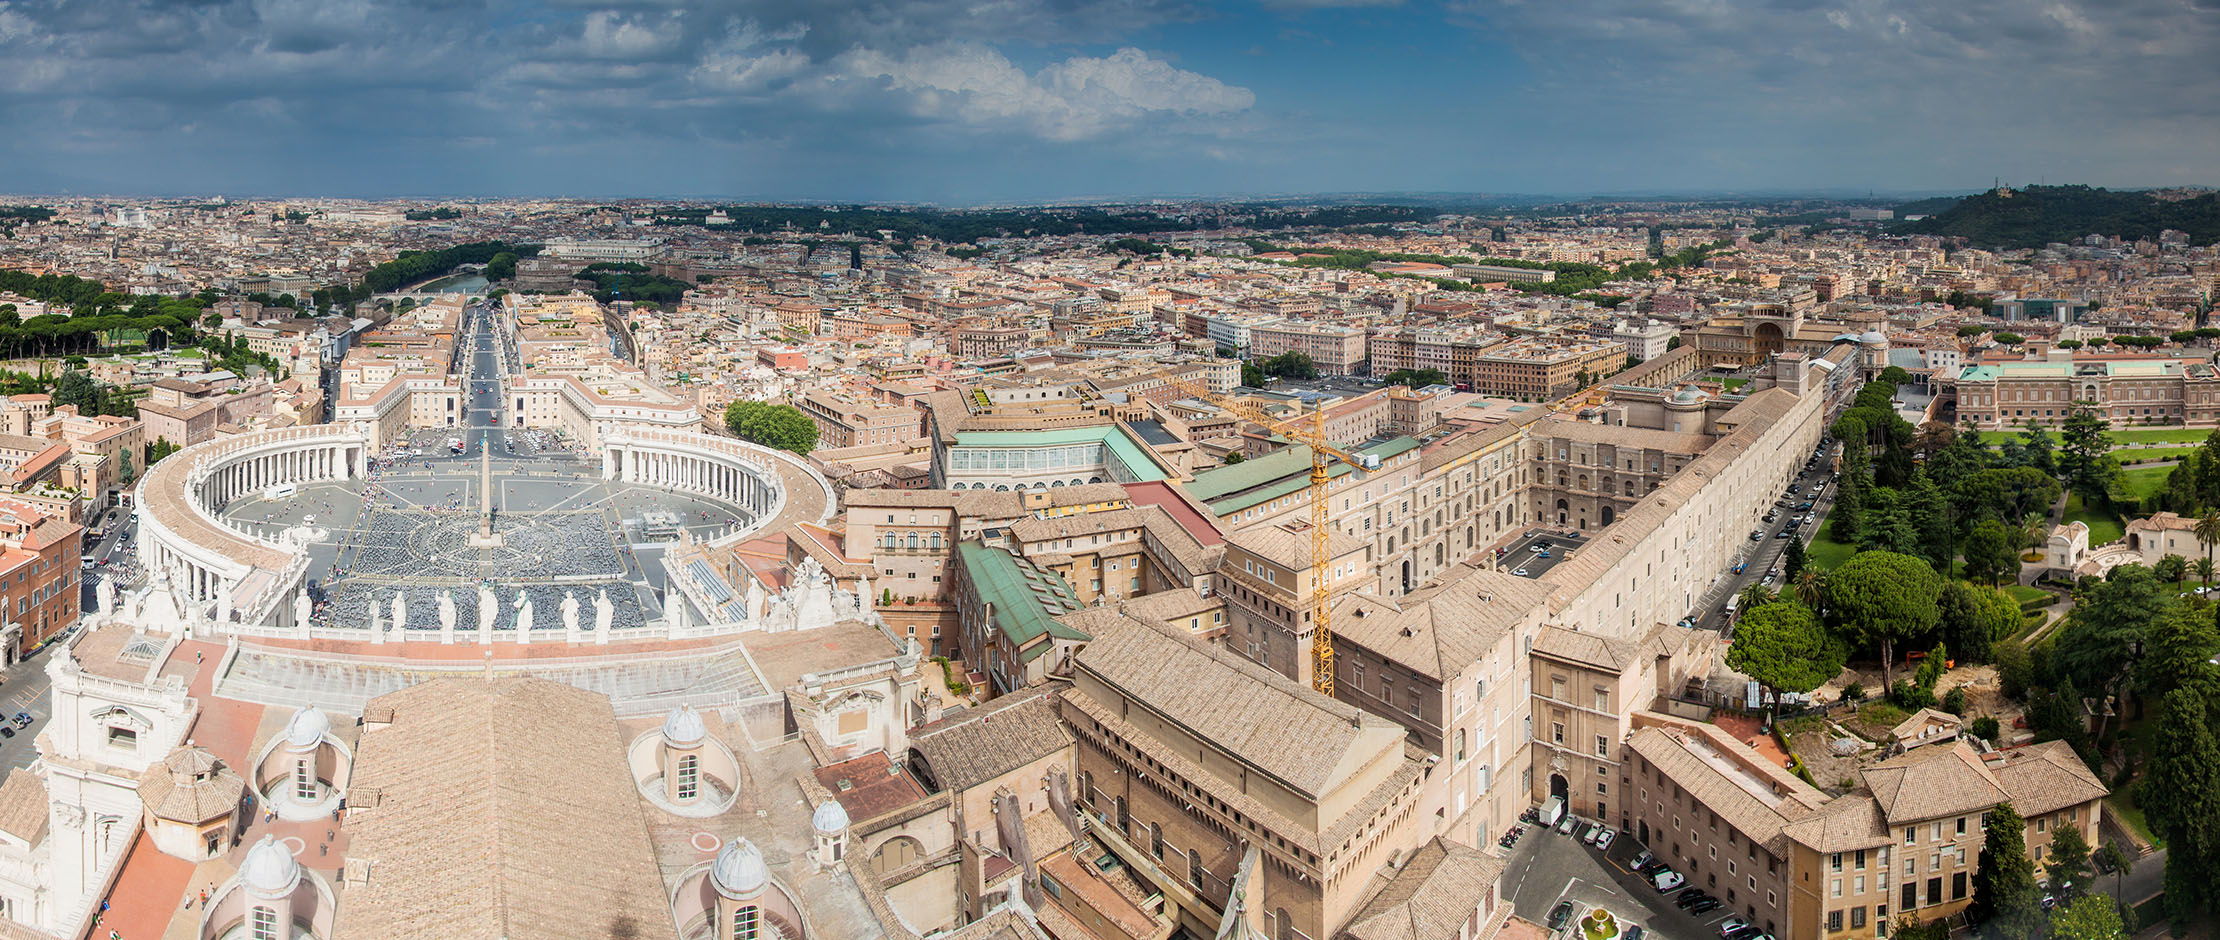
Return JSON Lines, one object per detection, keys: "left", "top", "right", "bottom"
{"left": 835, "top": 44, "right": 1257, "bottom": 140}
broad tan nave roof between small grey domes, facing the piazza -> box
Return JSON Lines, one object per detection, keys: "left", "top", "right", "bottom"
{"left": 331, "top": 678, "right": 677, "bottom": 940}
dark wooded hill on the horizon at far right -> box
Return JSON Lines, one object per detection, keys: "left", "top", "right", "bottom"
{"left": 1896, "top": 187, "right": 2220, "bottom": 249}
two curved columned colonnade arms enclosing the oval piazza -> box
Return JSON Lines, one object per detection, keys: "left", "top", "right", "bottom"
{"left": 134, "top": 424, "right": 835, "bottom": 642}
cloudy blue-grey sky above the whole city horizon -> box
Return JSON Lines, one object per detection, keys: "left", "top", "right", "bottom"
{"left": 0, "top": 0, "right": 2220, "bottom": 202}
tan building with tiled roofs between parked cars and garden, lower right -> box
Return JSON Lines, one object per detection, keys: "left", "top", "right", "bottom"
{"left": 1618, "top": 713, "right": 2107, "bottom": 940}
